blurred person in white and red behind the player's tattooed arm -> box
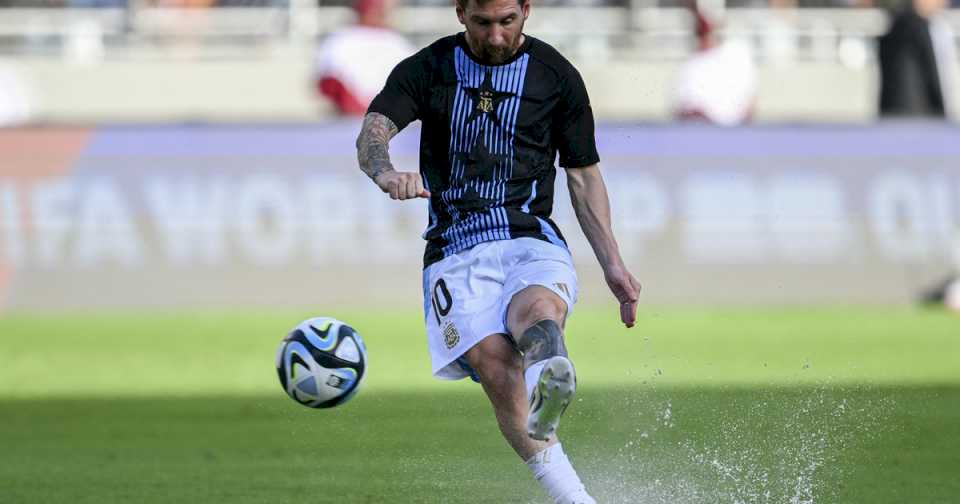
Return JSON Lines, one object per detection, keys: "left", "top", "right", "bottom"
{"left": 314, "top": 0, "right": 416, "bottom": 116}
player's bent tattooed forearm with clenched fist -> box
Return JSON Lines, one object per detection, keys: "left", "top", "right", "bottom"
{"left": 357, "top": 112, "right": 430, "bottom": 200}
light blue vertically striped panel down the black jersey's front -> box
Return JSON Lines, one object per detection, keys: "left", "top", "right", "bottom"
{"left": 442, "top": 47, "right": 530, "bottom": 257}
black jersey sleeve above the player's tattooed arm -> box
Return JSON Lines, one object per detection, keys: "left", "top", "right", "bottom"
{"left": 367, "top": 51, "right": 428, "bottom": 130}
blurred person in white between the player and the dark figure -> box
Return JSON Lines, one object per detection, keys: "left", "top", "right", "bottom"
{"left": 672, "top": 5, "right": 757, "bottom": 126}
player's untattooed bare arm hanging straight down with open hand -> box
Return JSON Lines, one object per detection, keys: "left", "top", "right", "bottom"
{"left": 566, "top": 164, "right": 640, "bottom": 327}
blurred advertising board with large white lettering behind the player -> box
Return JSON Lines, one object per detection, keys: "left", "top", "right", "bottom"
{"left": 0, "top": 122, "right": 960, "bottom": 311}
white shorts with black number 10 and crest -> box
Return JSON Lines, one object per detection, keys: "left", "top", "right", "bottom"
{"left": 423, "top": 238, "right": 577, "bottom": 380}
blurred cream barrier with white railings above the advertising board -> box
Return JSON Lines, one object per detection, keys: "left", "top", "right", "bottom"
{"left": 7, "top": 8, "right": 960, "bottom": 124}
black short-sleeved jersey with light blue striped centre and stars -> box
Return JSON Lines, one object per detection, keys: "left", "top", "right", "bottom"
{"left": 368, "top": 33, "right": 599, "bottom": 267}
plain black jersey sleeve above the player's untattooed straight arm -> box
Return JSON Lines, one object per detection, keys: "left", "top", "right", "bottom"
{"left": 555, "top": 66, "right": 600, "bottom": 168}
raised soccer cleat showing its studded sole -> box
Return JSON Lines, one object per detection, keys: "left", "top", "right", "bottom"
{"left": 527, "top": 355, "right": 577, "bottom": 441}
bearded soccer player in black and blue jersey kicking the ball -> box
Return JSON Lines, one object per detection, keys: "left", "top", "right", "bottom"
{"left": 357, "top": 0, "right": 640, "bottom": 498}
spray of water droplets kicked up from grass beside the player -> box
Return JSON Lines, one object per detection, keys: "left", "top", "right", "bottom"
{"left": 582, "top": 388, "right": 892, "bottom": 504}
